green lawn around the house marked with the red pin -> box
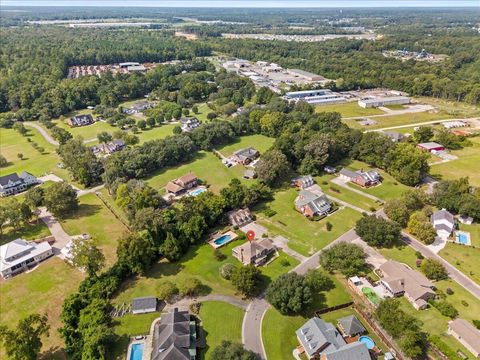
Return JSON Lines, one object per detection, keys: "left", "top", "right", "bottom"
{"left": 114, "top": 240, "right": 298, "bottom": 303}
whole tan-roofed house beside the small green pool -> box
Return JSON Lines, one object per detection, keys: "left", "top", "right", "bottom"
{"left": 379, "top": 260, "right": 435, "bottom": 310}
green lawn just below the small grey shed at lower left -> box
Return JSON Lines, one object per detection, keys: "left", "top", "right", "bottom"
{"left": 107, "top": 312, "right": 161, "bottom": 360}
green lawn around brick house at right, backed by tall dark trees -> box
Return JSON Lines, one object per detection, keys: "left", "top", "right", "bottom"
{"left": 347, "top": 160, "right": 409, "bottom": 200}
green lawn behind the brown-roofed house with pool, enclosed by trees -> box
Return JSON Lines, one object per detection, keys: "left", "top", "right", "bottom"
{"left": 147, "top": 151, "right": 238, "bottom": 192}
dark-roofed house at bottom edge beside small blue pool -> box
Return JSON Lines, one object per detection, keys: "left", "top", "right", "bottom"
{"left": 151, "top": 308, "right": 199, "bottom": 360}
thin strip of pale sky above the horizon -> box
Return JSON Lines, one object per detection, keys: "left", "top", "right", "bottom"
{"left": 0, "top": 0, "right": 480, "bottom": 9}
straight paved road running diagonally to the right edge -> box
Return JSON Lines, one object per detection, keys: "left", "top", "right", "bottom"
{"left": 402, "top": 232, "right": 480, "bottom": 299}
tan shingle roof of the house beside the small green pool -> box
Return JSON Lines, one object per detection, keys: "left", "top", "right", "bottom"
{"left": 380, "top": 260, "right": 433, "bottom": 300}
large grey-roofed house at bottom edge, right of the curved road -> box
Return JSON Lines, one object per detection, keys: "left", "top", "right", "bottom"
{"left": 296, "top": 317, "right": 371, "bottom": 360}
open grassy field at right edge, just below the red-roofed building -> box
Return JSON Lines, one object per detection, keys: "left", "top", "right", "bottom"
{"left": 430, "top": 137, "right": 480, "bottom": 186}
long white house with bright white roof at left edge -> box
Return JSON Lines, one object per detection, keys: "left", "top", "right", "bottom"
{"left": 0, "top": 239, "right": 53, "bottom": 279}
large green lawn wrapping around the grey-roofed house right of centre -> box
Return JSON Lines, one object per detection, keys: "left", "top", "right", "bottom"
{"left": 255, "top": 188, "right": 362, "bottom": 256}
